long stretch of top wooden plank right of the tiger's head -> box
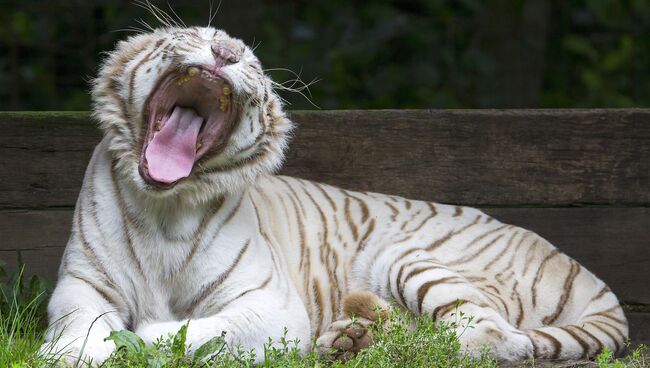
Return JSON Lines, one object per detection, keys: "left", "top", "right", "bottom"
{"left": 284, "top": 110, "right": 650, "bottom": 205}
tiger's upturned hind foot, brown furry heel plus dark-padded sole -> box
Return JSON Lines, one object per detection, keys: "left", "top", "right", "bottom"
{"left": 316, "top": 291, "right": 390, "bottom": 362}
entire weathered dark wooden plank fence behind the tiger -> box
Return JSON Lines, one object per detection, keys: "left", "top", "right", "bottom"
{"left": 0, "top": 109, "right": 650, "bottom": 343}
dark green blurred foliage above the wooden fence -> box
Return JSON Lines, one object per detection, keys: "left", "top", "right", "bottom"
{"left": 0, "top": 0, "right": 650, "bottom": 110}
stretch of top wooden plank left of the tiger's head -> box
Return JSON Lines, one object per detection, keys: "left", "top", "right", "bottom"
{"left": 0, "top": 112, "right": 100, "bottom": 208}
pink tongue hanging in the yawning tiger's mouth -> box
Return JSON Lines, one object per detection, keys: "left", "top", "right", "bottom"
{"left": 144, "top": 106, "right": 203, "bottom": 184}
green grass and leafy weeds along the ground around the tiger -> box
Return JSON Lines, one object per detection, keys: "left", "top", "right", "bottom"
{"left": 0, "top": 263, "right": 650, "bottom": 368}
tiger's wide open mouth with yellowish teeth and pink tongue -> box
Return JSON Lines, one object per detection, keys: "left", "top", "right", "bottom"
{"left": 139, "top": 66, "right": 235, "bottom": 188}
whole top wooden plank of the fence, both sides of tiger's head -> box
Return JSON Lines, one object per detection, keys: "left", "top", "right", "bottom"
{"left": 0, "top": 109, "right": 650, "bottom": 208}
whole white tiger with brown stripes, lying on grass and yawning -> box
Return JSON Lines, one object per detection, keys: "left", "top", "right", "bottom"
{"left": 47, "top": 27, "right": 628, "bottom": 364}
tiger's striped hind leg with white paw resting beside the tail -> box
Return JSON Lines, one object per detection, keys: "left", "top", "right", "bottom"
{"left": 380, "top": 252, "right": 534, "bottom": 361}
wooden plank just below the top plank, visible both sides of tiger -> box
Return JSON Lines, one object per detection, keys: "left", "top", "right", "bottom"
{"left": 0, "top": 208, "right": 650, "bottom": 304}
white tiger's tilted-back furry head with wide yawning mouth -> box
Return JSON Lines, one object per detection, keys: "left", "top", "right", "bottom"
{"left": 92, "top": 27, "right": 293, "bottom": 201}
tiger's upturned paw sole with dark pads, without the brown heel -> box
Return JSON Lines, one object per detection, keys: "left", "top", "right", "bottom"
{"left": 316, "top": 318, "right": 373, "bottom": 362}
